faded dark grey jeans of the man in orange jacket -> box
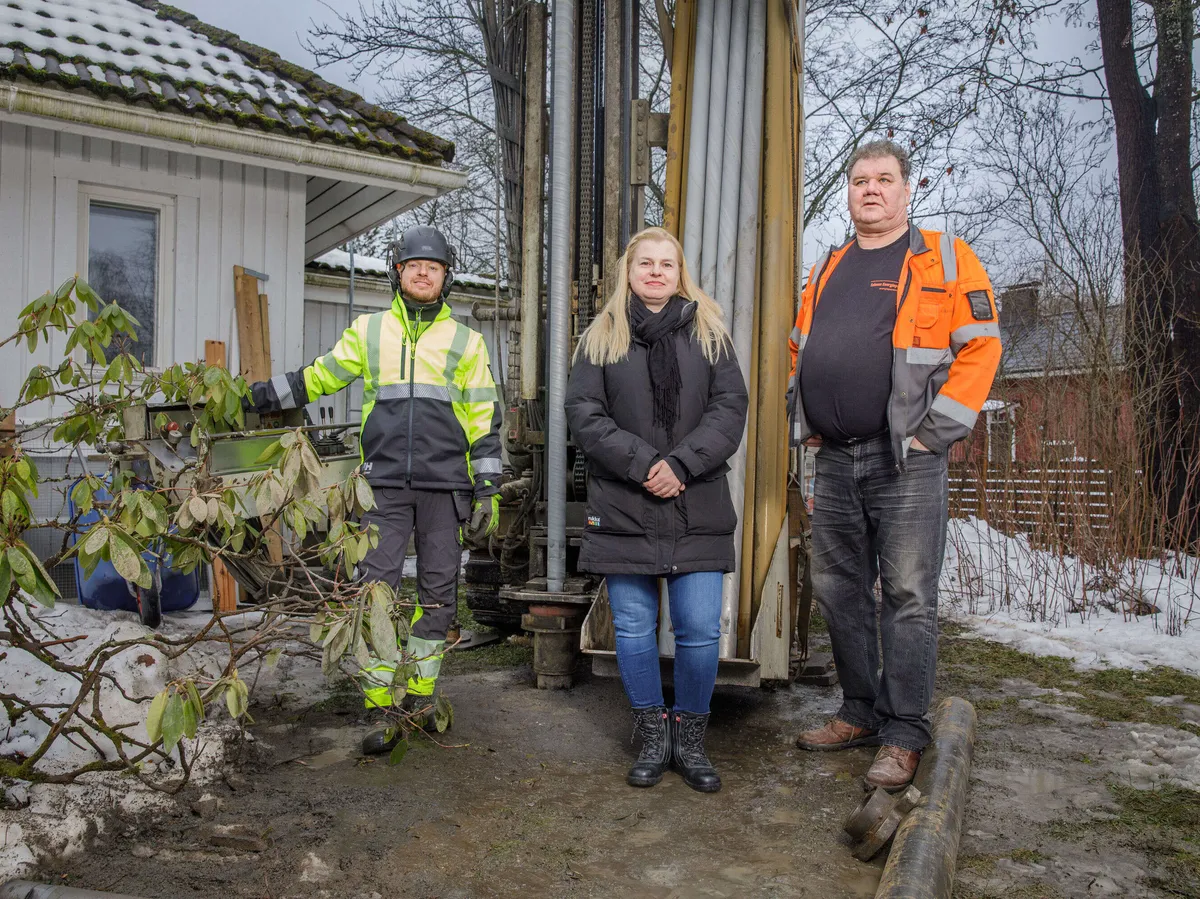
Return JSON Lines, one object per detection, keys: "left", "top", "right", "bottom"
{"left": 812, "top": 436, "right": 949, "bottom": 750}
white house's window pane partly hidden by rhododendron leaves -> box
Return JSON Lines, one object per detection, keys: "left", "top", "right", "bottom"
{"left": 88, "top": 200, "right": 162, "bottom": 367}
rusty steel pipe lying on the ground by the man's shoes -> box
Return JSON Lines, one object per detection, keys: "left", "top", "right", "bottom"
{"left": 875, "top": 696, "right": 976, "bottom": 899}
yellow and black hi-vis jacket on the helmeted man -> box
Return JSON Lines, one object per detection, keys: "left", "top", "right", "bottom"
{"left": 256, "top": 295, "right": 502, "bottom": 498}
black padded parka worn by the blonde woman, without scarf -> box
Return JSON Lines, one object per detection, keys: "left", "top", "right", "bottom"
{"left": 566, "top": 299, "right": 748, "bottom": 576}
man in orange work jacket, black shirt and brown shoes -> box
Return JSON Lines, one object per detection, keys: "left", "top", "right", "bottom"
{"left": 788, "top": 140, "right": 1001, "bottom": 791}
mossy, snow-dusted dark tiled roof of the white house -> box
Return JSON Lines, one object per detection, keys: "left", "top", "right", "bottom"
{"left": 0, "top": 0, "right": 454, "bottom": 164}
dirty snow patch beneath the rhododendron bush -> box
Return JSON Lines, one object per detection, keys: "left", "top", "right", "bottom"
{"left": 0, "top": 603, "right": 325, "bottom": 882}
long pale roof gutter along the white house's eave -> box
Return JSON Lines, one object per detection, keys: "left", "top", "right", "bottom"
{"left": 0, "top": 82, "right": 467, "bottom": 194}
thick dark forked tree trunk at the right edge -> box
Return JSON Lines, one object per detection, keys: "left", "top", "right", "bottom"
{"left": 1096, "top": 0, "right": 1200, "bottom": 545}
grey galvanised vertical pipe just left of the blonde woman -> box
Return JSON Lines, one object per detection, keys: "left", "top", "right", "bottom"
{"left": 546, "top": 0, "right": 575, "bottom": 593}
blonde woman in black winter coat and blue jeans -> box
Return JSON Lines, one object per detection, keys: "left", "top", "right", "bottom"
{"left": 566, "top": 228, "right": 746, "bottom": 792}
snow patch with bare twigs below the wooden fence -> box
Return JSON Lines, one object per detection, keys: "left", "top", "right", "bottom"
{"left": 938, "top": 519, "right": 1200, "bottom": 675}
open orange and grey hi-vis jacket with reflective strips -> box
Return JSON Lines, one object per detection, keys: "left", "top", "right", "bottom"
{"left": 787, "top": 226, "right": 1001, "bottom": 468}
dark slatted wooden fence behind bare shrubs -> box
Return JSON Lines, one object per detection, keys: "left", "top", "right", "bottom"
{"left": 950, "top": 462, "right": 1118, "bottom": 550}
